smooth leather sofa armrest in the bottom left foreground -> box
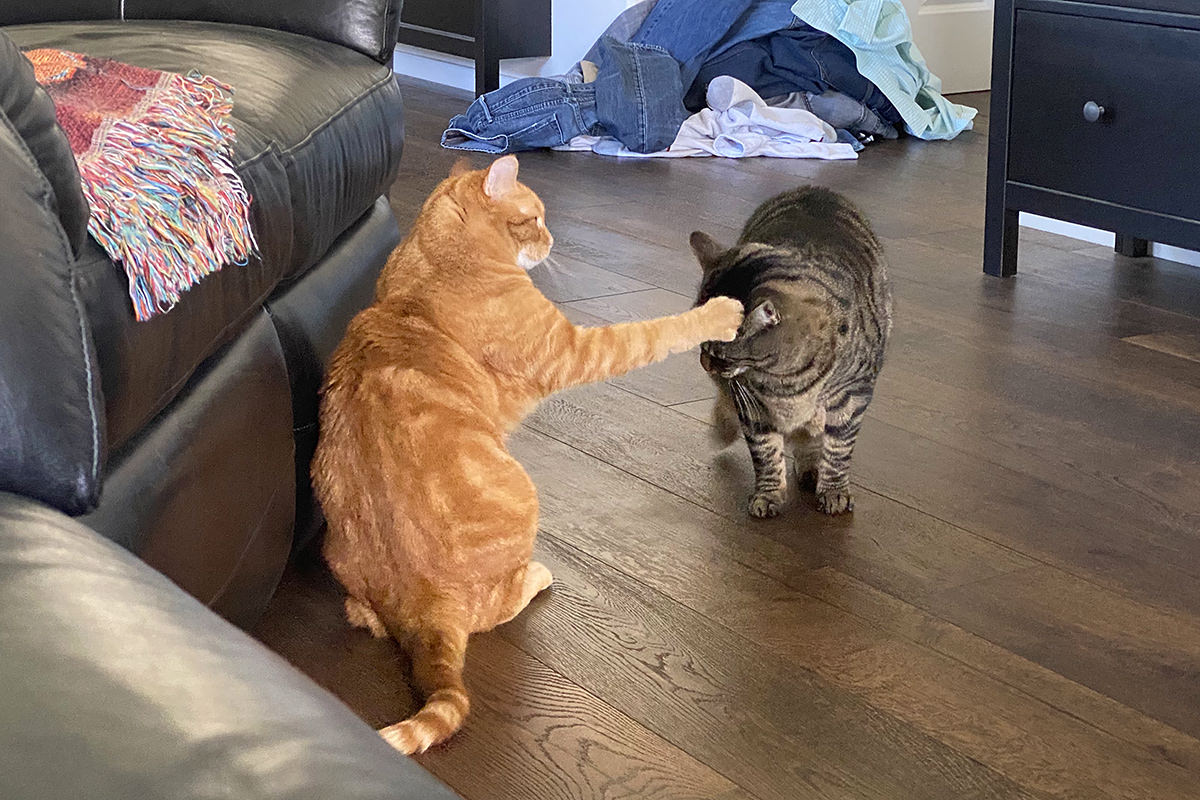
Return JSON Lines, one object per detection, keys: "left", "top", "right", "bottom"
{"left": 0, "top": 494, "right": 456, "bottom": 800}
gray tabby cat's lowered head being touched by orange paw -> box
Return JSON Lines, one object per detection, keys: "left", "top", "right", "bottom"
{"left": 692, "top": 236, "right": 846, "bottom": 378}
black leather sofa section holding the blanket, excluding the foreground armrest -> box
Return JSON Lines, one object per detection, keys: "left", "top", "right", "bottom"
{"left": 0, "top": 0, "right": 403, "bottom": 625}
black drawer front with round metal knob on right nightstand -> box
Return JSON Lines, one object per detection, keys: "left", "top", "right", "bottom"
{"left": 1008, "top": 11, "right": 1200, "bottom": 219}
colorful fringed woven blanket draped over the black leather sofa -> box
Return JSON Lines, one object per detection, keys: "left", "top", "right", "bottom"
{"left": 25, "top": 49, "right": 254, "bottom": 320}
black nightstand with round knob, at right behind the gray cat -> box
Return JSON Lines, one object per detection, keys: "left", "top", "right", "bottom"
{"left": 984, "top": 0, "right": 1200, "bottom": 276}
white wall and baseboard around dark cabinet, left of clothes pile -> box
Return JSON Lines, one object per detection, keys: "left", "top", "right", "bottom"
{"left": 392, "top": 0, "right": 638, "bottom": 91}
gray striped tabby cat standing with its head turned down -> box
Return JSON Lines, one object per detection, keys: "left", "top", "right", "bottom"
{"left": 691, "top": 186, "right": 892, "bottom": 517}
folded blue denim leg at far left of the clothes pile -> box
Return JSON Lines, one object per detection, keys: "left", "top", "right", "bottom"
{"left": 442, "top": 78, "right": 602, "bottom": 154}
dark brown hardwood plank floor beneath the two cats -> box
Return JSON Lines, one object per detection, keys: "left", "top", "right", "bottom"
{"left": 256, "top": 82, "right": 1200, "bottom": 800}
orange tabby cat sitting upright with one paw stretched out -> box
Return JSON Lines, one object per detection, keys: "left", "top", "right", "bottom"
{"left": 313, "top": 156, "right": 742, "bottom": 753}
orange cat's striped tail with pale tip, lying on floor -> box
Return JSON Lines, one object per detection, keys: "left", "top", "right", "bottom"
{"left": 379, "top": 632, "right": 470, "bottom": 756}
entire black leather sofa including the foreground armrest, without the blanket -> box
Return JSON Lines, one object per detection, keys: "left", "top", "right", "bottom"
{"left": 0, "top": 0, "right": 452, "bottom": 800}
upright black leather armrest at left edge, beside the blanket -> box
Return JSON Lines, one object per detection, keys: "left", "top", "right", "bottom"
{"left": 0, "top": 104, "right": 104, "bottom": 513}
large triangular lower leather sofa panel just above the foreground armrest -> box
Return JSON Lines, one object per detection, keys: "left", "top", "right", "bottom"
{"left": 82, "top": 308, "right": 296, "bottom": 625}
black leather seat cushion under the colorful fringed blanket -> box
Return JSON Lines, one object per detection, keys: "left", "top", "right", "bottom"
{"left": 5, "top": 22, "right": 403, "bottom": 449}
